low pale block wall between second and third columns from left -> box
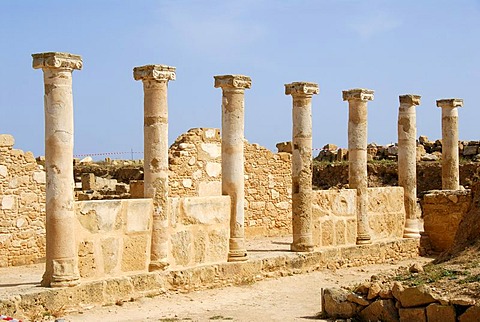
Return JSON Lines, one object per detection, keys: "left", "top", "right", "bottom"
{"left": 169, "top": 196, "right": 230, "bottom": 268}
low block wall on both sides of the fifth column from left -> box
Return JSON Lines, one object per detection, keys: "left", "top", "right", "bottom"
{"left": 312, "top": 187, "right": 405, "bottom": 247}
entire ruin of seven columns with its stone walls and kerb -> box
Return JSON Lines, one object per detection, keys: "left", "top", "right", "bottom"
{"left": 0, "top": 52, "right": 480, "bottom": 314}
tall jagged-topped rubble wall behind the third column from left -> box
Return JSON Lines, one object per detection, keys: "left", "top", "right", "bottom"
{"left": 169, "top": 128, "right": 292, "bottom": 238}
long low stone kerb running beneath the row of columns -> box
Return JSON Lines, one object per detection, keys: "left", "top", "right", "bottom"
{"left": 0, "top": 239, "right": 419, "bottom": 317}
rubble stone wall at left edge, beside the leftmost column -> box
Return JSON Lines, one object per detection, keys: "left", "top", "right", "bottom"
{"left": 0, "top": 134, "right": 45, "bottom": 267}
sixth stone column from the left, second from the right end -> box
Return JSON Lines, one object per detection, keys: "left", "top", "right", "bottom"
{"left": 398, "top": 95, "right": 421, "bottom": 238}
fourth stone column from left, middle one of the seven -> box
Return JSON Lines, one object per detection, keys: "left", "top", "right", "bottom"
{"left": 285, "top": 82, "right": 319, "bottom": 252}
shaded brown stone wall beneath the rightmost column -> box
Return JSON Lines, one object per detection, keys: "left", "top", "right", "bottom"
{"left": 421, "top": 190, "right": 472, "bottom": 252}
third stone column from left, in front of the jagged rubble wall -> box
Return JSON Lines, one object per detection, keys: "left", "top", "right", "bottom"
{"left": 214, "top": 75, "right": 252, "bottom": 262}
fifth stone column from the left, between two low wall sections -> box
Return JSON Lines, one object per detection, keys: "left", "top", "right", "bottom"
{"left": 343, "top": 88, "right": 374, "bottom": 245}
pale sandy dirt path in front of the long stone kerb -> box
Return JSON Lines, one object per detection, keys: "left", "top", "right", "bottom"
{"left": 65, "top": 258, "right": 429, "bottom": 322}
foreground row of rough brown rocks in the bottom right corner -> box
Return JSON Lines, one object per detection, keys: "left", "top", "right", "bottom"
{"left": 322, "top": 281, "right": 480, "bottom": 322}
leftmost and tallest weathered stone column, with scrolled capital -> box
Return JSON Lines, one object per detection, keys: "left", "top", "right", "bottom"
{"left": 32, "top": 52, "right": 82, "bottom": 287}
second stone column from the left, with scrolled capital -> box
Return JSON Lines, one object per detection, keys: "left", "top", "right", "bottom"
{"left": 133, "top": 65, "right": 175, "bottom": 271}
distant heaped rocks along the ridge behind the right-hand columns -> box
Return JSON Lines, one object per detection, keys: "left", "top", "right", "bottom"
{"left": 314, "top": 135, "right": 480, "bottom": 162}
